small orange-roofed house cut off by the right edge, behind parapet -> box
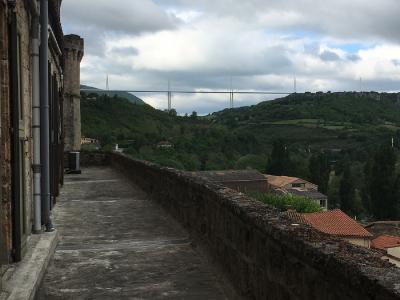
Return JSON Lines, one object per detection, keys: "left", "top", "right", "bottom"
{"left": 371, "top": 234, "right": 400, "bottom": 267}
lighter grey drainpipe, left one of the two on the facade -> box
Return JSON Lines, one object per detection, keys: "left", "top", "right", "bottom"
{"left": 32, "top": 1, "right": 42, "bottom": 234}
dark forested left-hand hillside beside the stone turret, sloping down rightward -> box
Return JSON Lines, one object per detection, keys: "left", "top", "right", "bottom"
{"left": 81, "top": 94, "right": 258, "bottom": 170}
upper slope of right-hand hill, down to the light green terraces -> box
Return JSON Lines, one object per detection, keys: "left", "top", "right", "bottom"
{"left": 213, "top": 92, "right": 400, "bottom": 126}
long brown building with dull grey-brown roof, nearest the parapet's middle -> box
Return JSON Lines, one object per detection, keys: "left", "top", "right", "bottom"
{"left": 188, "top": 170, "right": 269, "bottom": 193}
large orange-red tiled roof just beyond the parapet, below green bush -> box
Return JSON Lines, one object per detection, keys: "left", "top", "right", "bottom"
{"left": 287, "top": 209, "right": 372, "bottom": 238}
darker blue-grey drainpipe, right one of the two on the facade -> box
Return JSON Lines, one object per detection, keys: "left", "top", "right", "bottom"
{"left": 40, "top": 0, "right": 54, "bottom": 232}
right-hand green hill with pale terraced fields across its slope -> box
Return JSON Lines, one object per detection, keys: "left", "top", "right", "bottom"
{"left": 212, "top": 92, "right": 400, "bottom": 150}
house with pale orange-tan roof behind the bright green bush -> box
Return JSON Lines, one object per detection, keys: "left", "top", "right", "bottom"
{"left": 265, "top": 175, "right": 328, "bottom": 210}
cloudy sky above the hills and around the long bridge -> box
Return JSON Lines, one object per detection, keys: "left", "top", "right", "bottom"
{"left": 62, "top": 0, "right": 400, "bottom": 114}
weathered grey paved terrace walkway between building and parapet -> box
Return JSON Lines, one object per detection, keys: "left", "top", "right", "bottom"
{"left": 36, "top": 168, "right": 233, "bottom": 300}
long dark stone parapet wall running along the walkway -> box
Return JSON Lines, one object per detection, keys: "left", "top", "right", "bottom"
{"left": 82, "top": 153, "right": 400, "bottom": 300}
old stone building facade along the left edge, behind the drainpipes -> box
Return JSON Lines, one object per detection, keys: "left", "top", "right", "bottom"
{"left": 0, "top": 0, "right": 83, "bottom": 272}
